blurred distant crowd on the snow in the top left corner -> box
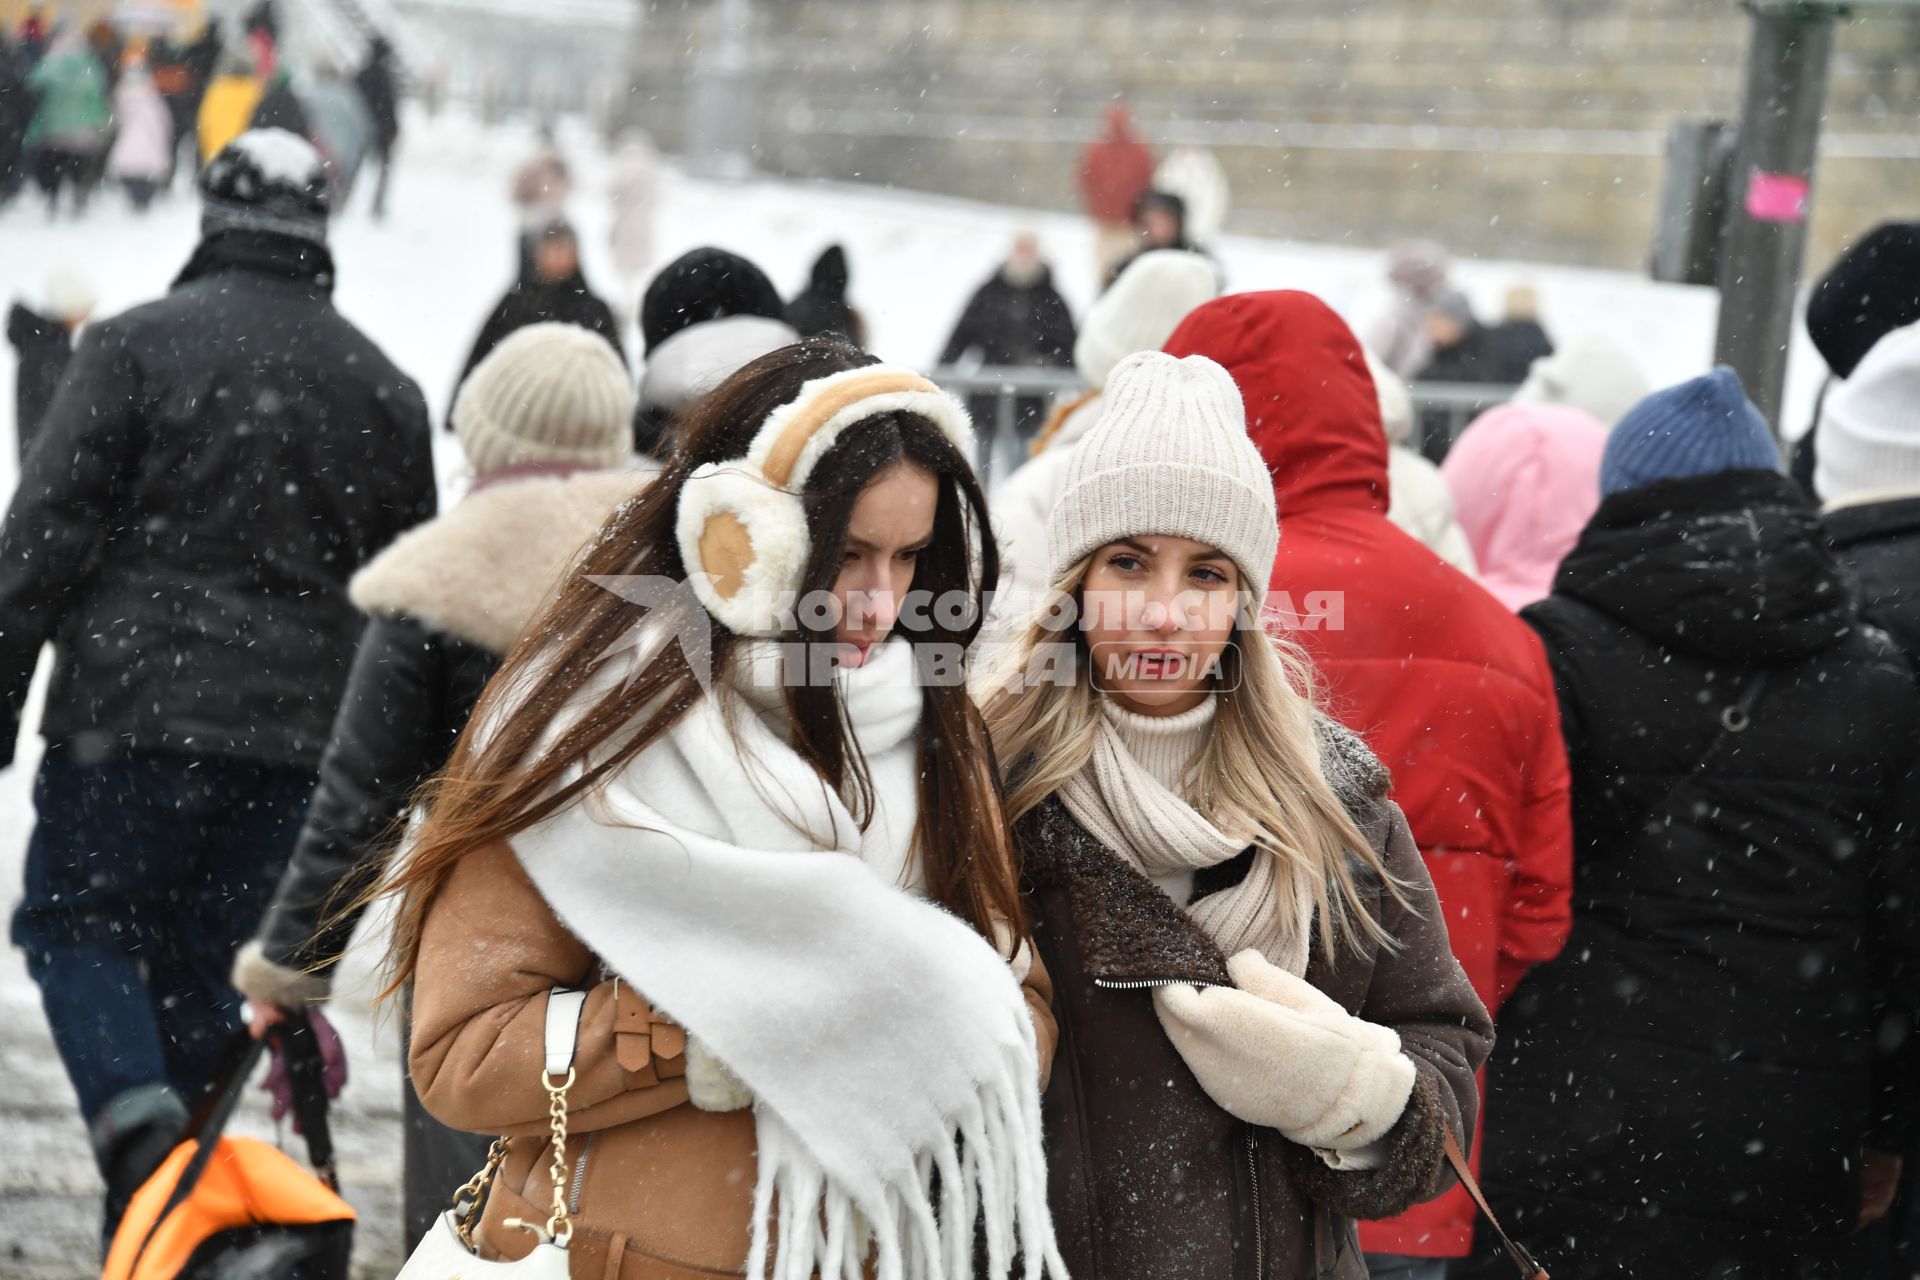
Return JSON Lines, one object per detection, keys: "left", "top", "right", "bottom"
{"left": 0, "top": 0, "right": 399, "bottom": 217}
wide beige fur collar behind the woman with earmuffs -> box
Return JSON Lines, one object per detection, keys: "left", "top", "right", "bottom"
{"left": 349, "top": 472, "right": 651, "bottom": 654}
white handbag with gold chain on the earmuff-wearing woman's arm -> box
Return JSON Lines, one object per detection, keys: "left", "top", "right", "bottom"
{"left": 396, "top": 988, "right": 588, "bottom": 1280}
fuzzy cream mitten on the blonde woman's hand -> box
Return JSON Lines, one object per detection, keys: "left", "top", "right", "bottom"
{"left": 1154, "top": 950, "right": 1415, "bottom": 1151}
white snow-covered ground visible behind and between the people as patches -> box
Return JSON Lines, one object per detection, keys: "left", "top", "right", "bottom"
{"left": 0, "top": 105, "right": 1818, "bottom": 1280}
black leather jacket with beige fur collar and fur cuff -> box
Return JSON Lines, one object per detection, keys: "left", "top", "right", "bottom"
{"left": 236, "top": 472, "right": 645, "bottom": 1006}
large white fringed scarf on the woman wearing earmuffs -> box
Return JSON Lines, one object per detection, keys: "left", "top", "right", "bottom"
{"left": 513, "top": 643, "right": 1066, "bottom": 1280}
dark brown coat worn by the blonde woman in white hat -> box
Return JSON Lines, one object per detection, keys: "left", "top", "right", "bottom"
{"left": 1018, "top": 727, "right": 1492, "bottom": 1280}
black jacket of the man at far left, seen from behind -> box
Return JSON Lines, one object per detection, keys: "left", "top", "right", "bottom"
{"left": 0, "top": 232, "right": 434, "bottom": 770}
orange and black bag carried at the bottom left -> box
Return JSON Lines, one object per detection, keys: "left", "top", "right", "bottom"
{"left": 100, "top": 1013, "right": 355, "bottom": 1280}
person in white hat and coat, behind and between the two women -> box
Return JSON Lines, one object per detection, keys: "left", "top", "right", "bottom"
{"left": 993, "top": 249, "right": 1219, "bottom": 617}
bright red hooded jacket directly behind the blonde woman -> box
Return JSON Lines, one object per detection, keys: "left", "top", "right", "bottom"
{"left": 1165, "top": 292, "right": 1572, "bottom": 1257}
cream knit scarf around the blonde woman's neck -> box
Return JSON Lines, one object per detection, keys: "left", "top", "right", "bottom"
{"left": 1060, "top": 695, "right": 1313, "bottom": 977}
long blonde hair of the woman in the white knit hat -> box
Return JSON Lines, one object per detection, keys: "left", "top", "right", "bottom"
{"left": 981, "top": 557, "right": 1411, "bottom": 956}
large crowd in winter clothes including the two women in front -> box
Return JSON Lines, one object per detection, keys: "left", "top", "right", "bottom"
{"left": 0, "top": 84, "right": 1920, "bottom": 1280}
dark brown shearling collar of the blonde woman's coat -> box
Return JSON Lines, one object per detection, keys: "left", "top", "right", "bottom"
{"left": 1016, "top": 716, "right": 1392, "bottom": 986}
